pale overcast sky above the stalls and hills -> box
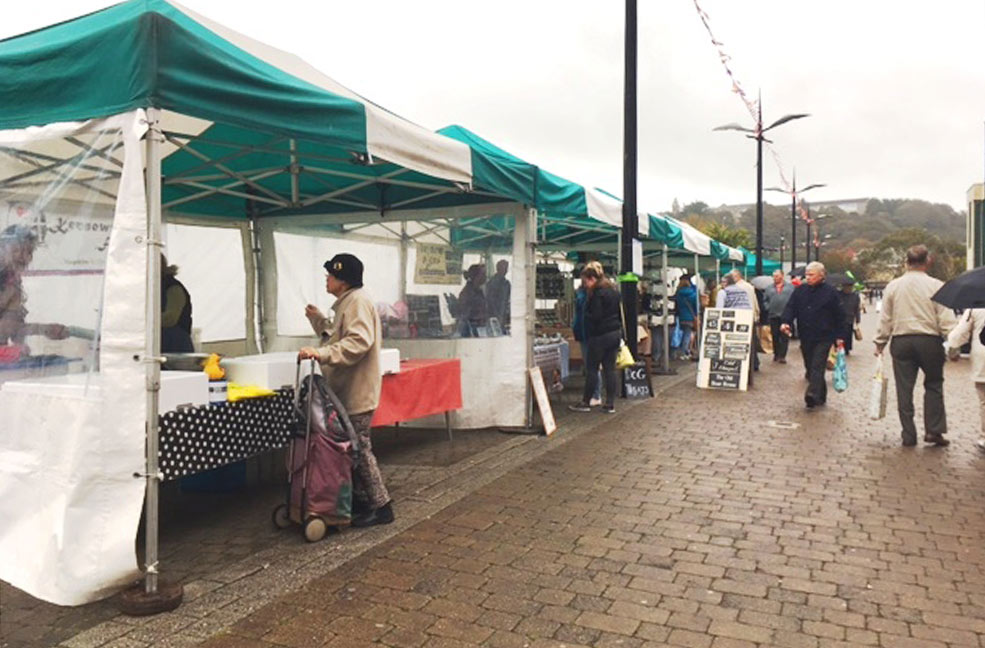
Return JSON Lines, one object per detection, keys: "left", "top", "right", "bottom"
{"left": 7, "top": 0, "right": 985, "bottom": 211}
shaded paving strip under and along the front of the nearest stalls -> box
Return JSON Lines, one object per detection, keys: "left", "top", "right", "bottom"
{"left": 0, "top": 360, "right": 684, "bottom": 648}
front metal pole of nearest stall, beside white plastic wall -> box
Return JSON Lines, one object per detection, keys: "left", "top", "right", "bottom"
{"left": 144, "top": 108, "right": 164, "bottom": 594}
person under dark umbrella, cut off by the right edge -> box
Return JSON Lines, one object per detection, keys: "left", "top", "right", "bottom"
{"left": 931, "top": 267, "right": 985, "bottom": 451}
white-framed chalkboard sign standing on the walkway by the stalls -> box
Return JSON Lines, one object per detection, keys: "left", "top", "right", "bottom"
{"left": 698, "top": 308, "right": 755, "bottom": 391}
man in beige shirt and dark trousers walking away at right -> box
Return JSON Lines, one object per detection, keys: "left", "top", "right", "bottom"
{"left": 875, "top": 245, "right": 957, "bottom": 447}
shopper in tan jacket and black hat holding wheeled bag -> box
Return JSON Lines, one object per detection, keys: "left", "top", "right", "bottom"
{"left": 298, "top": 254, "right": 394, "bottom": 527}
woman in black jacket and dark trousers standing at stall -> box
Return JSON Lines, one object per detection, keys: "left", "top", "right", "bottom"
{"left": 570, "top": 266, "right": 622, "bottom": 414}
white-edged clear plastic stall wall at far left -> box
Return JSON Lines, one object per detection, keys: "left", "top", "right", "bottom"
{"left": 0, "top": 112, "right": 146, "bottom": 605}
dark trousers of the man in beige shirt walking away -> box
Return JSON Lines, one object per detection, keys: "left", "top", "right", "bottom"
{"left": 889, "top": 335, "right": 947, "bottom": 443}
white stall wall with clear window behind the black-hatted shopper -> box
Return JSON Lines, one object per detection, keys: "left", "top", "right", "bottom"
{"left": 263, "top": 216, "right": 527, "bottom": 428}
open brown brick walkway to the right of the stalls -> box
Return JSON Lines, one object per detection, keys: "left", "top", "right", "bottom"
{"left": 9, "top": 308, "right": 985, "bottom": 648}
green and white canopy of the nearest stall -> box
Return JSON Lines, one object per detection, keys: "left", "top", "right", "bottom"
{"left": 0, "top": 0, "right": 486, "bottom": 218}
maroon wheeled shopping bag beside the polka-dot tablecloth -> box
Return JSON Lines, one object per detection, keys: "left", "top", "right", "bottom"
{"left": 273, "top": 360, "right": 359, "bottom": 542}
